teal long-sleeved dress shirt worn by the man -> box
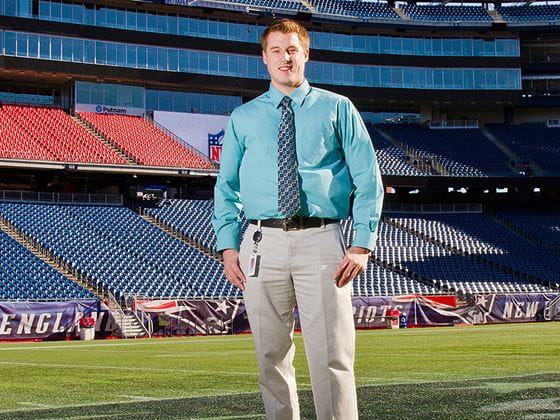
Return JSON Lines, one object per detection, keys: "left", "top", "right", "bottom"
{"left": 212, "top": 81, "right": 383, "bottom": 251}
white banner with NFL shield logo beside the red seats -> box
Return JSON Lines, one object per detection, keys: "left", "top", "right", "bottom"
{"left": 154, "top": 111, "right": 229, "bottom": 158}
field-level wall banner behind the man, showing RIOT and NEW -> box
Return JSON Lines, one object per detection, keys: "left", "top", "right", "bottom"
{"left": 135, "top": 294, "right": 560, "bottom": 335}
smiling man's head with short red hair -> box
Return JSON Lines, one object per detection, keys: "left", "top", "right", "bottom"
{"left": 261, "top": 19, "right": 309, "bottom": 94}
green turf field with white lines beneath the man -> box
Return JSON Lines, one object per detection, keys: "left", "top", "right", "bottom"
{"left": 0, "top": 323, "right": 560, "bottom": 419}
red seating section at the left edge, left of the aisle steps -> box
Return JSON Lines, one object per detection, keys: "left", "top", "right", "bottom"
{"left": 0, "top": 105, "right": 127, "bottom": 164}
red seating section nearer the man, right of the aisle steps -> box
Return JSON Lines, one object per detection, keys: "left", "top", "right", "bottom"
{"left": 78, "top": 112, "right": 214, "bottom": 169}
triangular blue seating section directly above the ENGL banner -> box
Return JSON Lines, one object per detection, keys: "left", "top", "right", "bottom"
{"left": 0, "top": 231, "right": 94, "bottom": 300}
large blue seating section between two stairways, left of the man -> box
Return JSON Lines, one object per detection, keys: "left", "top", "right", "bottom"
{"left": 0, "top": 203, "right": 240, "bottom": 299}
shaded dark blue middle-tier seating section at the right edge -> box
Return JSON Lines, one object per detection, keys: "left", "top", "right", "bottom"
{"left": 486, "top": 123, "right": 560, "bottom": 175}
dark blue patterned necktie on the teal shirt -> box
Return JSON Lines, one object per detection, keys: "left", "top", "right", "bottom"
{"left": 278, "top": 96, "right": 300, "bottom": 218}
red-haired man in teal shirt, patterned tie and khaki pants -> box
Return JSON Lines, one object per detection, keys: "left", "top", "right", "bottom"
{"left": 213, "top": 20, "right": 383, "bottom": 419}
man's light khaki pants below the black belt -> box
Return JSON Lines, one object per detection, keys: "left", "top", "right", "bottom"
{"left": 239, "top": 223, "right": 358, "bottom": 420}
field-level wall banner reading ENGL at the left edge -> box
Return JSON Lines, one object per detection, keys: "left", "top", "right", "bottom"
{"left": 0, "top": 300, "right": 115, "bottom": 340}
